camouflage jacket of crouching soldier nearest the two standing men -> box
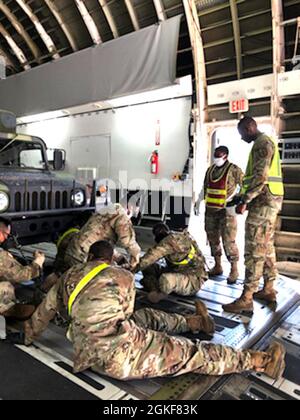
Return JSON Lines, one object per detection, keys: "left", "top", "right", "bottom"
{"left": 140, "top": 231, "right": 207, "bottom": 278}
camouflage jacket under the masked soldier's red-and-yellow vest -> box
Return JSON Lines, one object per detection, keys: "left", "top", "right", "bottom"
{"left": 204, "top": 162, "right": 244, "bottom": 213}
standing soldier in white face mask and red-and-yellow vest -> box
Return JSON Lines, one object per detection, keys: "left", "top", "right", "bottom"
{"left": 204, "top": 146, "right": 244, "bottom": 284}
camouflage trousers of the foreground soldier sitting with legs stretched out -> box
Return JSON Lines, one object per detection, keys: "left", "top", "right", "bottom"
{"left": 92, "top": 316, "right": 253, "bottom": 380}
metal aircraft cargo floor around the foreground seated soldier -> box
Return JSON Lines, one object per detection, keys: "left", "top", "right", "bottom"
{"left": 0, "top": 260, "right": 300, "bottom": 400}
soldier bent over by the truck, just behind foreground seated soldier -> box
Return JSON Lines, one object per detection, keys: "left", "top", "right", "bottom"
{"left": 65, "top": 204, "right": 141, "bottom": 269}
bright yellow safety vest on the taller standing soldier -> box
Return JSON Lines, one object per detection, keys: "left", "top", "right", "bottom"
{"left": 242, "top": 137, "right": 284, "bottom": 197}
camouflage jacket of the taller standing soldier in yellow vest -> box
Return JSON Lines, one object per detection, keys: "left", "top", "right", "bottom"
{"left": 243, "top": 133, "right": 283, "bottom": 210}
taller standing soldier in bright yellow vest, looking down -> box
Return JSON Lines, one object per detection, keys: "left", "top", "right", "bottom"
{"left": 223, "top": 117, "right": 284, "bottom": 313}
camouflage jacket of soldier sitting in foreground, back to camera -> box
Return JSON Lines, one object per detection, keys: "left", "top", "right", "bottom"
{"left": 30, "top": 260, "right": 136, "bottom": 372}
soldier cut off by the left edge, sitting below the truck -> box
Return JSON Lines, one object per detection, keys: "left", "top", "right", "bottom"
{"left": 0, "top": 219, "right": 45, "bottom": 326}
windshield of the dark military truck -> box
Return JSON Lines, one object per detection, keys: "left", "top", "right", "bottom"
{"left": 0, "top": 138, "right": 46, "bottom": 170}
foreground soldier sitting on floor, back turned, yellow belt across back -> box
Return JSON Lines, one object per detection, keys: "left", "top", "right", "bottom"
{"left": 25, "top": 242, "right": 285, "bottom": 380}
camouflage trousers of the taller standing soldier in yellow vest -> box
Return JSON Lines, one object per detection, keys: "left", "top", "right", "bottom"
{"left": 245, "top": 206, "right": 278, "bottom": 293}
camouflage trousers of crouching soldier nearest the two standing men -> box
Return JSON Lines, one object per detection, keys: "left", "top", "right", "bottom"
{"left": 141, "top": 264, "right": 206, "bottom": 296}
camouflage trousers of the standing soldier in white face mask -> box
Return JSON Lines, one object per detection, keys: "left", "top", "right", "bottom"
{"left": 205, "top": 210, "right": 239, "bottom": 263}
